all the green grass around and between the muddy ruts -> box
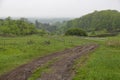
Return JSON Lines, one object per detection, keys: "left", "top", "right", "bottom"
{"left": 0, "top": 35, "right": 120, "bottom": 80}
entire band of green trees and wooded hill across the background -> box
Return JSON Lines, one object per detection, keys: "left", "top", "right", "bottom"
{"left": 0, "top": 10, "right": 120, "bottom": 35}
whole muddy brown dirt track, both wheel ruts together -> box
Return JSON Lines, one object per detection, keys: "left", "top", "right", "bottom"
{"left": 0, "top": 44, "right": 97, "bottom": 80}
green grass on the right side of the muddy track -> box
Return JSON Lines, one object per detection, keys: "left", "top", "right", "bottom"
{"left": 73, "top": 36, "right": 120, "bottom": 80}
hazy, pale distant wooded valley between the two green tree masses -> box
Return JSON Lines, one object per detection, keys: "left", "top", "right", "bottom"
{"left": 31, "top": 18, "right": 70, "bottom": 32}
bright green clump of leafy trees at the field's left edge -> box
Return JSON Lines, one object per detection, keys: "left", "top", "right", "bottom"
{"left": 0, "top": 17, "right": 36, "bottom": 35}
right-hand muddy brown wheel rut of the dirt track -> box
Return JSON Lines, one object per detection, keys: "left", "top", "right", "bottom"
{"left": 38, "top": 44, "right": 97, "bottom": 80}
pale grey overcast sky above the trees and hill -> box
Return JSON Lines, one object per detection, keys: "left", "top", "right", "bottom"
{"left": 0, "top": 0, "right": 120, "bottom": 18}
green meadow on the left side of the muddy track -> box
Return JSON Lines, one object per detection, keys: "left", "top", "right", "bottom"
{"left": 0, "top": 35, "right": 89, "bottom": 75}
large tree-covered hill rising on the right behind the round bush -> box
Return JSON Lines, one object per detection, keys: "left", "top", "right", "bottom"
{"left": 62, "top": 10, "right": 120, "bottom": 33}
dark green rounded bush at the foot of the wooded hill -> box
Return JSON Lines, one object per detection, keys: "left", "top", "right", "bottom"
{"left": 65, "top": 28, "right": 87, "bottom": 36}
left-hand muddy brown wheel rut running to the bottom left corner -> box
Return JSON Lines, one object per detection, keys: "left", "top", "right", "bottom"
{"left": 0, "top": 46, "right": 81, "bottom": 80}
